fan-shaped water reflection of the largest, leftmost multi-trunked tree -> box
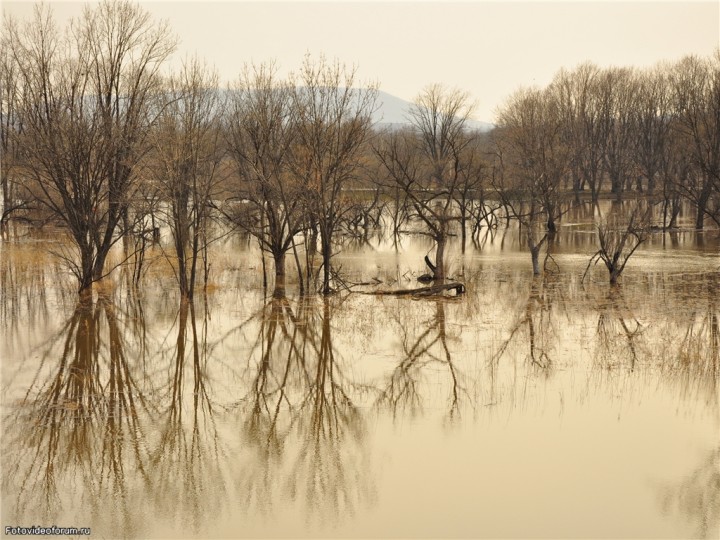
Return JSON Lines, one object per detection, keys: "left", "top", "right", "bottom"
{"left": 3, "top": 296, "right": 150, "bottom": 531}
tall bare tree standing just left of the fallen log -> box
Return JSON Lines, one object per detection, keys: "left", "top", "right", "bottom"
{"left": 291, "top": 56, "right": 377, "bottom": 294}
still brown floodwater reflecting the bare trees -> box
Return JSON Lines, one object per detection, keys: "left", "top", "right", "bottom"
{"left": 0, "top": 205, "right": 720, "bottom": 538}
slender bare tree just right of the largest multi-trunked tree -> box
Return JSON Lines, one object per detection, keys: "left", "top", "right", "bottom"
{"left": 148, "top": 58, "right": 224, "bottom": 299}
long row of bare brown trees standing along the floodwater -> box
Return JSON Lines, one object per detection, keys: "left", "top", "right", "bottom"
{"left": 0, "top": 2, "right": 720, "bottom": 299}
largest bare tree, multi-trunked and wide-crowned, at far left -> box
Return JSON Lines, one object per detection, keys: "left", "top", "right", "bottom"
{"left": 8, "top": 1, "right": 175, "bottom": 292}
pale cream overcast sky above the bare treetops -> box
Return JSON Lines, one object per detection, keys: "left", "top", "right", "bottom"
{"left": 2, "top": 0, "right": 720, "bottom": 121}
